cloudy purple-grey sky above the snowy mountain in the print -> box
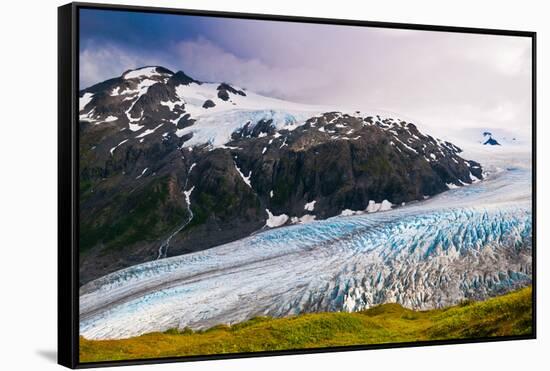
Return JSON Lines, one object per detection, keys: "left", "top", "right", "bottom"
{"left": 80, "top": 10, "right": 531, "bottom": 139}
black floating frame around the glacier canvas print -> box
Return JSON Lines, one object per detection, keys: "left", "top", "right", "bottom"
{"left": 58, "top": 3, "right": 537, "bottom": 368}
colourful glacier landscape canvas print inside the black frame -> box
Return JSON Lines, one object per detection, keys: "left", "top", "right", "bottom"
{"left": 78, "top": 9, "right": 533, "bottom": 363}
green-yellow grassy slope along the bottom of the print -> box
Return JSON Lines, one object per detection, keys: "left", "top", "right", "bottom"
{"left": 80, "top": 287, "right": 532, "bottom": 362}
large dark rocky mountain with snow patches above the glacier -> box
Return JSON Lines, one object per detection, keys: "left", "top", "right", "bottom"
{"left": 79, "top": 66, "right": 482, "bottom": 284}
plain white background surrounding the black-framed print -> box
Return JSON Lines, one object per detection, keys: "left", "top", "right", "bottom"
{"left": 0, "top": 0, "right": 550, "bottom": 371}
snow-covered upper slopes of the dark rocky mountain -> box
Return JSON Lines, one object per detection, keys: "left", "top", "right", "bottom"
{"left": 80, "top": 66, "right": 478, "bottom": 158}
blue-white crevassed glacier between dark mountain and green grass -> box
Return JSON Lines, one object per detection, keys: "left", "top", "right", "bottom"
{"left": 80, "top": 168, "right": 532, "bottom": 339}
